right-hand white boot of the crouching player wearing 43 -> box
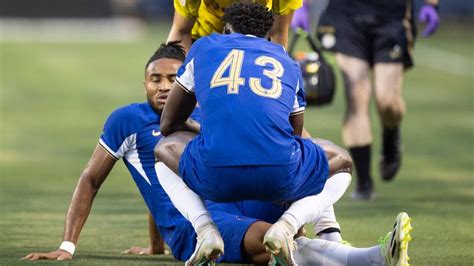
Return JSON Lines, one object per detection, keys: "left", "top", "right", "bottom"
{"left": 263, "top": 220, "right": 297, "bottom": 266}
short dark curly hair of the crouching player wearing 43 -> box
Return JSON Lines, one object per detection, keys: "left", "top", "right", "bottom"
{"left": 222, "top": 2, "right": 273, "bottom": 38}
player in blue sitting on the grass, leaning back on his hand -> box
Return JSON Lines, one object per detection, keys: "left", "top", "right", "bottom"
{"left": 24, "top": 43, "right": 412, "bottom": 265}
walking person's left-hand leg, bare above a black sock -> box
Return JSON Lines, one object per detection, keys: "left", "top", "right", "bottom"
{"left": 336, "top": 53, "right": 374, "bottom": 200}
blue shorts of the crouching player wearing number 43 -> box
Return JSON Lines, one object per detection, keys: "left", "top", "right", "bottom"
{"left": 179, "top": 137, "right": 329, "bottom": 202}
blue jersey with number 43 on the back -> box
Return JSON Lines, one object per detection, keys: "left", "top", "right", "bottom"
{"left": 176, "top": 33, "right": 306, "bottom": 167}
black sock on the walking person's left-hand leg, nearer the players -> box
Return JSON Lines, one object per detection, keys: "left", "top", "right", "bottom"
{"left": 349, "top": 145, "right": 372, "bottom": 187}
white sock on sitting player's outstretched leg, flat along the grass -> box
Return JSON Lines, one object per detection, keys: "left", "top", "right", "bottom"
{"left": 293, "top": 237, "right": 385, "bottom": 266}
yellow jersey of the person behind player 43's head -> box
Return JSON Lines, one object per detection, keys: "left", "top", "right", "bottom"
{"left": 174, "top": 0, "right": 303, "bottom": 39}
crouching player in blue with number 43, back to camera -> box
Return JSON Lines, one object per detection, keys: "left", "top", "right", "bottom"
{"left": 155, "top": 3, "right": 410, "bottom": 265}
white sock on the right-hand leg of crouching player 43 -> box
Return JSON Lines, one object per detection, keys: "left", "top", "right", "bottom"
{"left": 280, "top": 173, "right": 351, "bottom": 232}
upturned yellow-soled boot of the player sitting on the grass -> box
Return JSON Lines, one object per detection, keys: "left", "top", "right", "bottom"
{"left": 379, "top": 212, "right": 413, "bottom": 266}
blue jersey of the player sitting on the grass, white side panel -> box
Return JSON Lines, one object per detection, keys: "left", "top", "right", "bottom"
{"left": 99, "top": 103, "right": 199, "bottom": 256}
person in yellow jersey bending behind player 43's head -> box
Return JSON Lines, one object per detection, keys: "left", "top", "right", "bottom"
{"left": 167, "top": 0, "right": 303, "bottom": 50}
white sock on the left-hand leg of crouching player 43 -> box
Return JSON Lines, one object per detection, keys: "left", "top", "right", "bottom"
{"left": 155, "top": 162, "right": 212, "bottom": 232}
